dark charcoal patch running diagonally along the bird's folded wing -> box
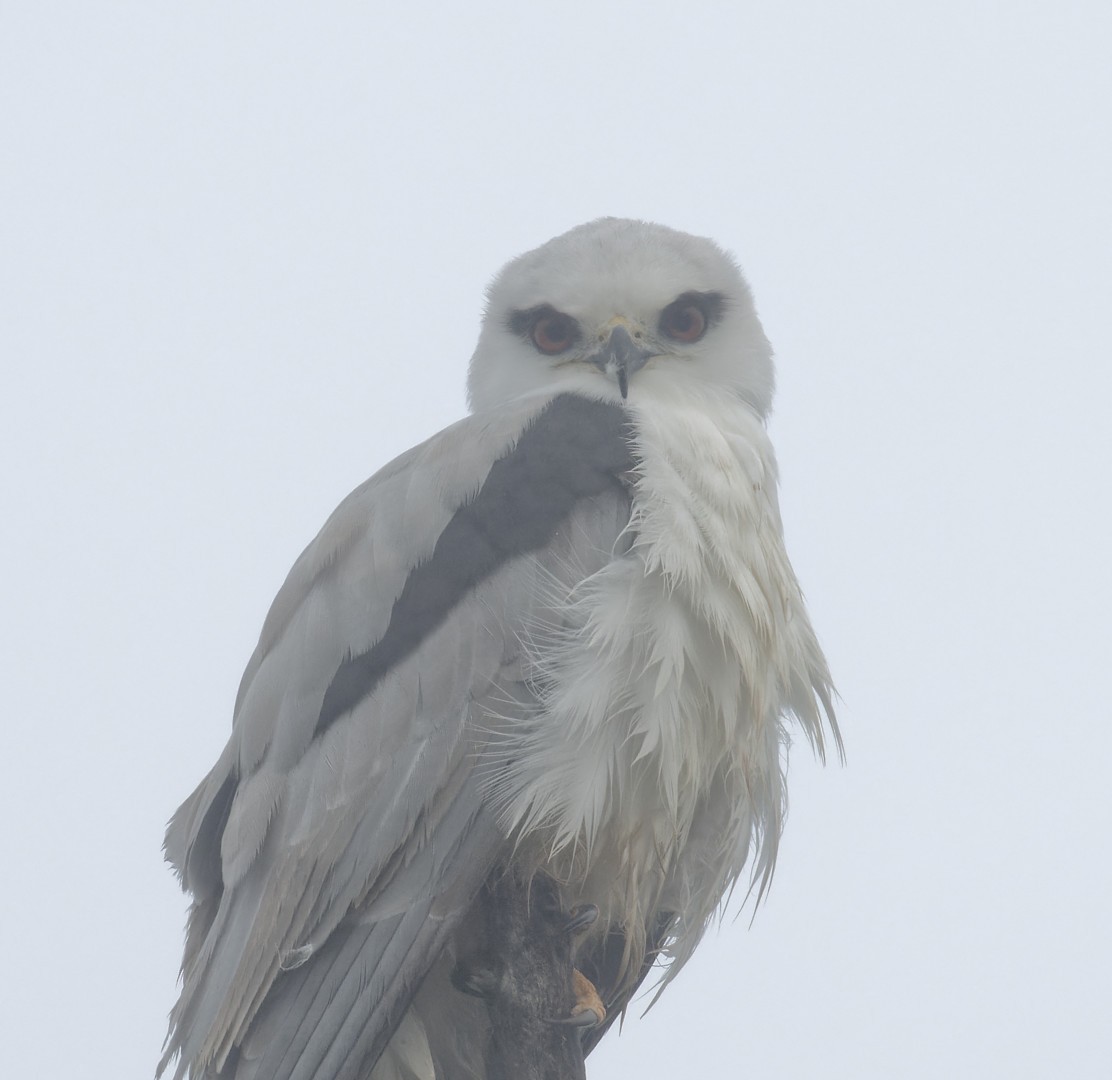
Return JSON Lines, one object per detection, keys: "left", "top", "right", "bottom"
{"left": 315, "top": 394, "right": 634, "bottom": 735}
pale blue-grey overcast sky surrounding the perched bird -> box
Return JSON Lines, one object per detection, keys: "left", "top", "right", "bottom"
{"left": 0, "top": 0, "right": 1112, "bottom": 1080}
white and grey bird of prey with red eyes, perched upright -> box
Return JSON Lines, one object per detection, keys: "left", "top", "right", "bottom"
{"left": 159, "top": 218, "right": 841, "bottom": 1080}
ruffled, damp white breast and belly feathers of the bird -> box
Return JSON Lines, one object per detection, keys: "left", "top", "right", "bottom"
{"left": 491, "top": 392, "right": 836, "bottom": 961}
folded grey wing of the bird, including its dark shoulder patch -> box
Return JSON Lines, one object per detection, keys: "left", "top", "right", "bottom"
{"left": 160, "top": 396, "right": 631, "bottom": 1080}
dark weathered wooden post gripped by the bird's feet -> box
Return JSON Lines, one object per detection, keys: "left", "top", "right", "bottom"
{"left": 454, "top": 871, "right": 597, "bottom": 1080}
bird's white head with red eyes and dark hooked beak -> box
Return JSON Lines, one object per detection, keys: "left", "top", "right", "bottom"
{"left": 467, "top": 218, "right": 774, "bottom": 416}
